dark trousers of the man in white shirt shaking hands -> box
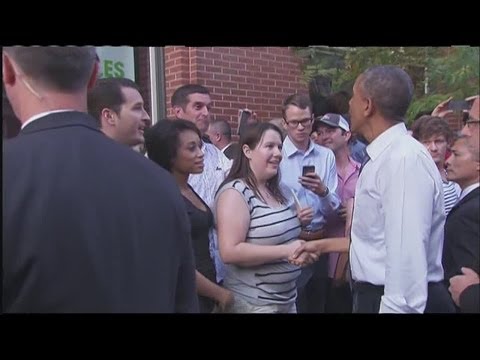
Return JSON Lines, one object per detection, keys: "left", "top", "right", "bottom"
{"left": 353, "top": 281, "right": 456, "bottom": 314}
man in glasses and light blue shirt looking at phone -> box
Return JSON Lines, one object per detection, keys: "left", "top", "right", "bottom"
{"left": 280, "top": 94, "right": 340, "bottom": 313}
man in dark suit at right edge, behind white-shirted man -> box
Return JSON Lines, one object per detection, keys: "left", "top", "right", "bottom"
{"left": 442, "top": 135, "right": 480, "bottom": 312}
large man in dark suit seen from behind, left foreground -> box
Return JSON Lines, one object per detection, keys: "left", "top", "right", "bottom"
{"left": 3, "top": 46, "right": 198, "bottom": 313}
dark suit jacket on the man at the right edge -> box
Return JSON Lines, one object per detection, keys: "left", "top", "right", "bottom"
{"left": 442, "top": 188, "right": 480, "bottom": 284}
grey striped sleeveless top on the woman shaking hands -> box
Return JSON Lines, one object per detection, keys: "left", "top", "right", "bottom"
{"left": 217, "top": 180, "right": 301, "bottom": 306}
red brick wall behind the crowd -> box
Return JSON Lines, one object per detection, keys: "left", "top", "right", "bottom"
{"left": 165, "top": 46, "right": 307, "bottom": 133}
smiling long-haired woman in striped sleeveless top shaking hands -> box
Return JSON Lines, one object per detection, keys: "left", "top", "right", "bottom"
{"left": 215, "top": 123, "right": 315, "bottom": 313}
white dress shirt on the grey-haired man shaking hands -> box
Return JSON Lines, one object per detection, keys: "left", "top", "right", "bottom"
{"left": 350, "top": 123, "right": 445, "bottom": 313}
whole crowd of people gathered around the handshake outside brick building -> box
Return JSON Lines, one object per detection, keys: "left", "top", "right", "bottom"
{"left": 3, "top": 46, "right": 480, "bottom": 313}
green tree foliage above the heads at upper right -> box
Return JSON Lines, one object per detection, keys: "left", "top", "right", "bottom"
{"left": 296, "top": 46, "right": 480, "bottom": 122}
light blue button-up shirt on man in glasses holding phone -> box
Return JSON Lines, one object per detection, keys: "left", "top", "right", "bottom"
{"left": 280, "top": 136, "right": 340, "bottom": 231}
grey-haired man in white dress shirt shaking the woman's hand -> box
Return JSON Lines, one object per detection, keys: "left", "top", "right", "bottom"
{"left": 350, "top": 66, "right": 454, "bottom": 313}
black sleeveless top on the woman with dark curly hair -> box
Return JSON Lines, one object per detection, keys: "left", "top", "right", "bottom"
{"left": 183, "top": 185, "right": 216, "bottom": 313}
